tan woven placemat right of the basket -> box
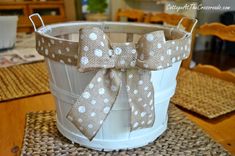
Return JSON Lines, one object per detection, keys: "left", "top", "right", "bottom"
{"left": 171, "top": 68, "right": 235, "bottom": 119}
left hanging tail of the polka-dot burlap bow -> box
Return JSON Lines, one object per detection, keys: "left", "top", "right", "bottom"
{"left": 67, "top": 69, "right": 121, "bottom": 140}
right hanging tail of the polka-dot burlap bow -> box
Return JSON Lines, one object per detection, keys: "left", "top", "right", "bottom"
{"left": 126, "top": 69, "right": 155, "bottom": 131}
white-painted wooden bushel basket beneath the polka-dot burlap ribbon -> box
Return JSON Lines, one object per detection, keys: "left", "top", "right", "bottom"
{"left": 29, "top": 14, "right": 195, "bottom": 151}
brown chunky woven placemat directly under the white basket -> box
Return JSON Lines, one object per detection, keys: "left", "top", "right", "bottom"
{"left": 21, "top": 105, "right": 229, "bottom": 156}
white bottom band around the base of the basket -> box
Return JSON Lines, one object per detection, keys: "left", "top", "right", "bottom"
{"left": 56, "top": 116, "right": 167, "bottom": 151}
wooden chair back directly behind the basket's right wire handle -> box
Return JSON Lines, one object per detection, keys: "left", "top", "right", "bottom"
{"left": 144, "top": 13, "right": 195, "bottom": 68}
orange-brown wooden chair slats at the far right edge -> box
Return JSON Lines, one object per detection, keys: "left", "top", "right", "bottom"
{"left": 194, "top": 23, "right": 235, "bottom": 83}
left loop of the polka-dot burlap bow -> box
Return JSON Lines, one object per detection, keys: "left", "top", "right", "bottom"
{"left": 77, "top": 28, "right": 115, "bottom": 72}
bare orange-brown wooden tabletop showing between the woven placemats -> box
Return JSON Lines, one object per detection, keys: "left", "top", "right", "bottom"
{"left": 0, "top": 94, "right": 235, "bottom": 156}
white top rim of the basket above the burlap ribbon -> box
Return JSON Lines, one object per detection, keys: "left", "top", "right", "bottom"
{"left": 35, "top": 21, "right": 191, "bottom": 43}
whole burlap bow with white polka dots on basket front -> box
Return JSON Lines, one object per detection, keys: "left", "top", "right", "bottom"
{"left": 67, "top": 28, "right": 189, "bottom": 140}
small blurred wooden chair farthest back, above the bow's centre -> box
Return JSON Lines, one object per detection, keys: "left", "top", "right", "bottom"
{"left": 116, "top": 9, "right": 145, "bottom": 22}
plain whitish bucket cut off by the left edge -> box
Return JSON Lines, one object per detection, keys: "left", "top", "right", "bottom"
{"left": 0, "top": 16, "right": 18, "bottom": 50}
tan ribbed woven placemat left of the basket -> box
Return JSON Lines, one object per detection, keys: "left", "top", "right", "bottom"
{"left": 0, "top": 62, "right": 49, "bottom": 102}
